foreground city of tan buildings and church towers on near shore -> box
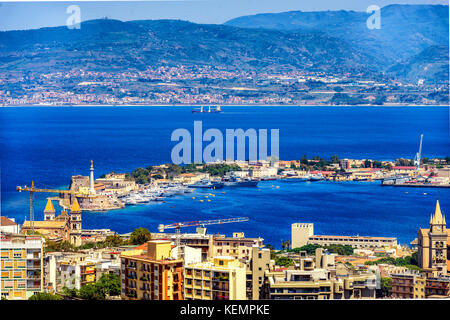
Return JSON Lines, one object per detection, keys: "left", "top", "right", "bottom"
{"left": 0, "top": 200, "right": 450, "bottom": 300}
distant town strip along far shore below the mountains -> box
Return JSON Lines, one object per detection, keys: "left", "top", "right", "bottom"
{"left": 0, "top": 65, "right": 449, "bottom": 106}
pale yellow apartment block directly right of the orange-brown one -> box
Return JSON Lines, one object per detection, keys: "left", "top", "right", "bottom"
{"left": 184, "top": 256, "right": 246, "bottom": 300}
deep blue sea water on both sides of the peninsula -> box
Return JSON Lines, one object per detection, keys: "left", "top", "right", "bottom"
{"left": 0, "top": 106, "right": 450, "bottom": 247}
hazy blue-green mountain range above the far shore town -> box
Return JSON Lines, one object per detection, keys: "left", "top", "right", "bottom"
{"left": 0, "top": 5, "right": 449, "bottom": 83}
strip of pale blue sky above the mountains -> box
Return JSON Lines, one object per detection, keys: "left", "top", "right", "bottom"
{"left": 0, "top": 0, "right": 448, "bottom": 30}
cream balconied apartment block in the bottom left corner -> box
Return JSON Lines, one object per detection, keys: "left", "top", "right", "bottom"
{"left": 0, "top": 233, "right": 44, "bottom": 300}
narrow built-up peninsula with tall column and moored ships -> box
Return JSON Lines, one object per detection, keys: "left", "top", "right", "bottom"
{"left": 36, "top": 157, "right": 450, "bottom": 211}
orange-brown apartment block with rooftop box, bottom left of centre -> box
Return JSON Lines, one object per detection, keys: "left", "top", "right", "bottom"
{"left": 120, "top": 240, "right": 183, "bottom": 300}
